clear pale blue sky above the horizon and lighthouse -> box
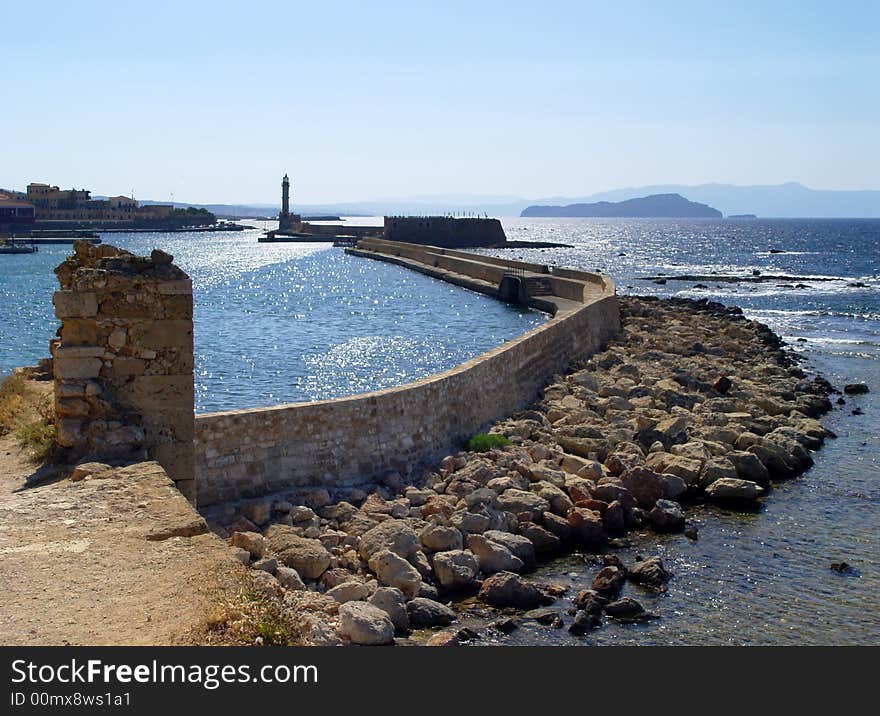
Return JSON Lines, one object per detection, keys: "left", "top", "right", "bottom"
{"left": 0, "top": 0, "right": 880, "bottom": 203}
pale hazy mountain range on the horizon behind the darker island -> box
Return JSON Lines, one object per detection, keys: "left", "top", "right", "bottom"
{"left": 134, "top": 183, "right": 880, "bottom": 218}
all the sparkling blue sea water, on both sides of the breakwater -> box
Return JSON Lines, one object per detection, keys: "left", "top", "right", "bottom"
{"left": 0, "top": 218, "right": 880, "bottom": 645}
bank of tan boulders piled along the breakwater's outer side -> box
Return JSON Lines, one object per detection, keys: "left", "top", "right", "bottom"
{"left": 207, "top": 297, "right": 836, "bottom": 645}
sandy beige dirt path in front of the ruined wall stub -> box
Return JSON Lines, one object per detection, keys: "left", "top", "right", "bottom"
{"left": 0, "top": 436, "right": 242, "bottom": 645}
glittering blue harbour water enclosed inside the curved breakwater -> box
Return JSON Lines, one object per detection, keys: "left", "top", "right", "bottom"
{"left": 0, "top": 224, "right": 547, "bottom": 412}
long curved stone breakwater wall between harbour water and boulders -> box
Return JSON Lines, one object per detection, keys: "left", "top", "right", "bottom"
{"left": 195, "top": 239, "right": 620, "bottom": 506}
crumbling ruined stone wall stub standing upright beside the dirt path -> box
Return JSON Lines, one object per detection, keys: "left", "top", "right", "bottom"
{"left": 50, "top": 241, "right": 196, "bottom": 501}
